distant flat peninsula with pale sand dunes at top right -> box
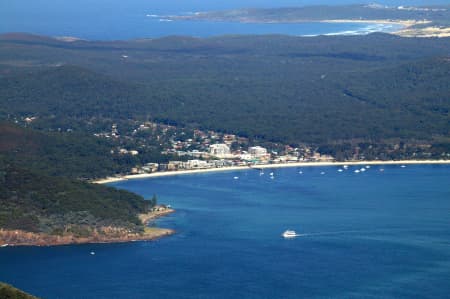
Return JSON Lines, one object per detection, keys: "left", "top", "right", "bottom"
{"left": 164, "top": 4, "right": 450, "bottom": 37}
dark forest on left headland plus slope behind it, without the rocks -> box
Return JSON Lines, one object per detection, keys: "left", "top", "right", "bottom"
{"left": 0, "top": 123, "right": 150, "bottom": 234}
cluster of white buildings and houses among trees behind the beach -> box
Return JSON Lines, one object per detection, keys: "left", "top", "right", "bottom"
{"left": 95, "top": 122, "right": 335, "bottom": 174}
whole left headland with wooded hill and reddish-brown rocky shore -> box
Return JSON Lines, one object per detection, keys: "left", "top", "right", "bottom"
{"left": 0, "top": 123, "right": 174, "bottom": 247}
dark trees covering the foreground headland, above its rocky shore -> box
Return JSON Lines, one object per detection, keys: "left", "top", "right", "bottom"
{"left": 0, "top": 164, "right": 149, "bottom": 235}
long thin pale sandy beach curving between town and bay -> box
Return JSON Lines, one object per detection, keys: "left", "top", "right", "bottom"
{"left": 93, "top": 160, "right": 450, "bottom": 184}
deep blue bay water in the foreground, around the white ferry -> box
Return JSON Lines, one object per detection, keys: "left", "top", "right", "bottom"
{"left": 0, "top": 165, "right": 450, "bottom": 298}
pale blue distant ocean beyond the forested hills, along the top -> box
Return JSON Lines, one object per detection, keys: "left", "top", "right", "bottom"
{"left": 0, "top": 0, "right": 448, "bottom": 40}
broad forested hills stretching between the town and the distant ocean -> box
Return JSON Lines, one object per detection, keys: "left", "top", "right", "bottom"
{"left": 0, "top": 34, "right": 450, "bottom": 145}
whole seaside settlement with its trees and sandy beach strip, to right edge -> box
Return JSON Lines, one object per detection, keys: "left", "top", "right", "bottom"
{"left": 15, "top": 115, "right": 450, "bottom": 183}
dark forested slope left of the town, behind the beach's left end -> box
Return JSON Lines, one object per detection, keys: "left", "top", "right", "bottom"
{"left": 0, "top": 123, "right": 130, "bottom": 178}
